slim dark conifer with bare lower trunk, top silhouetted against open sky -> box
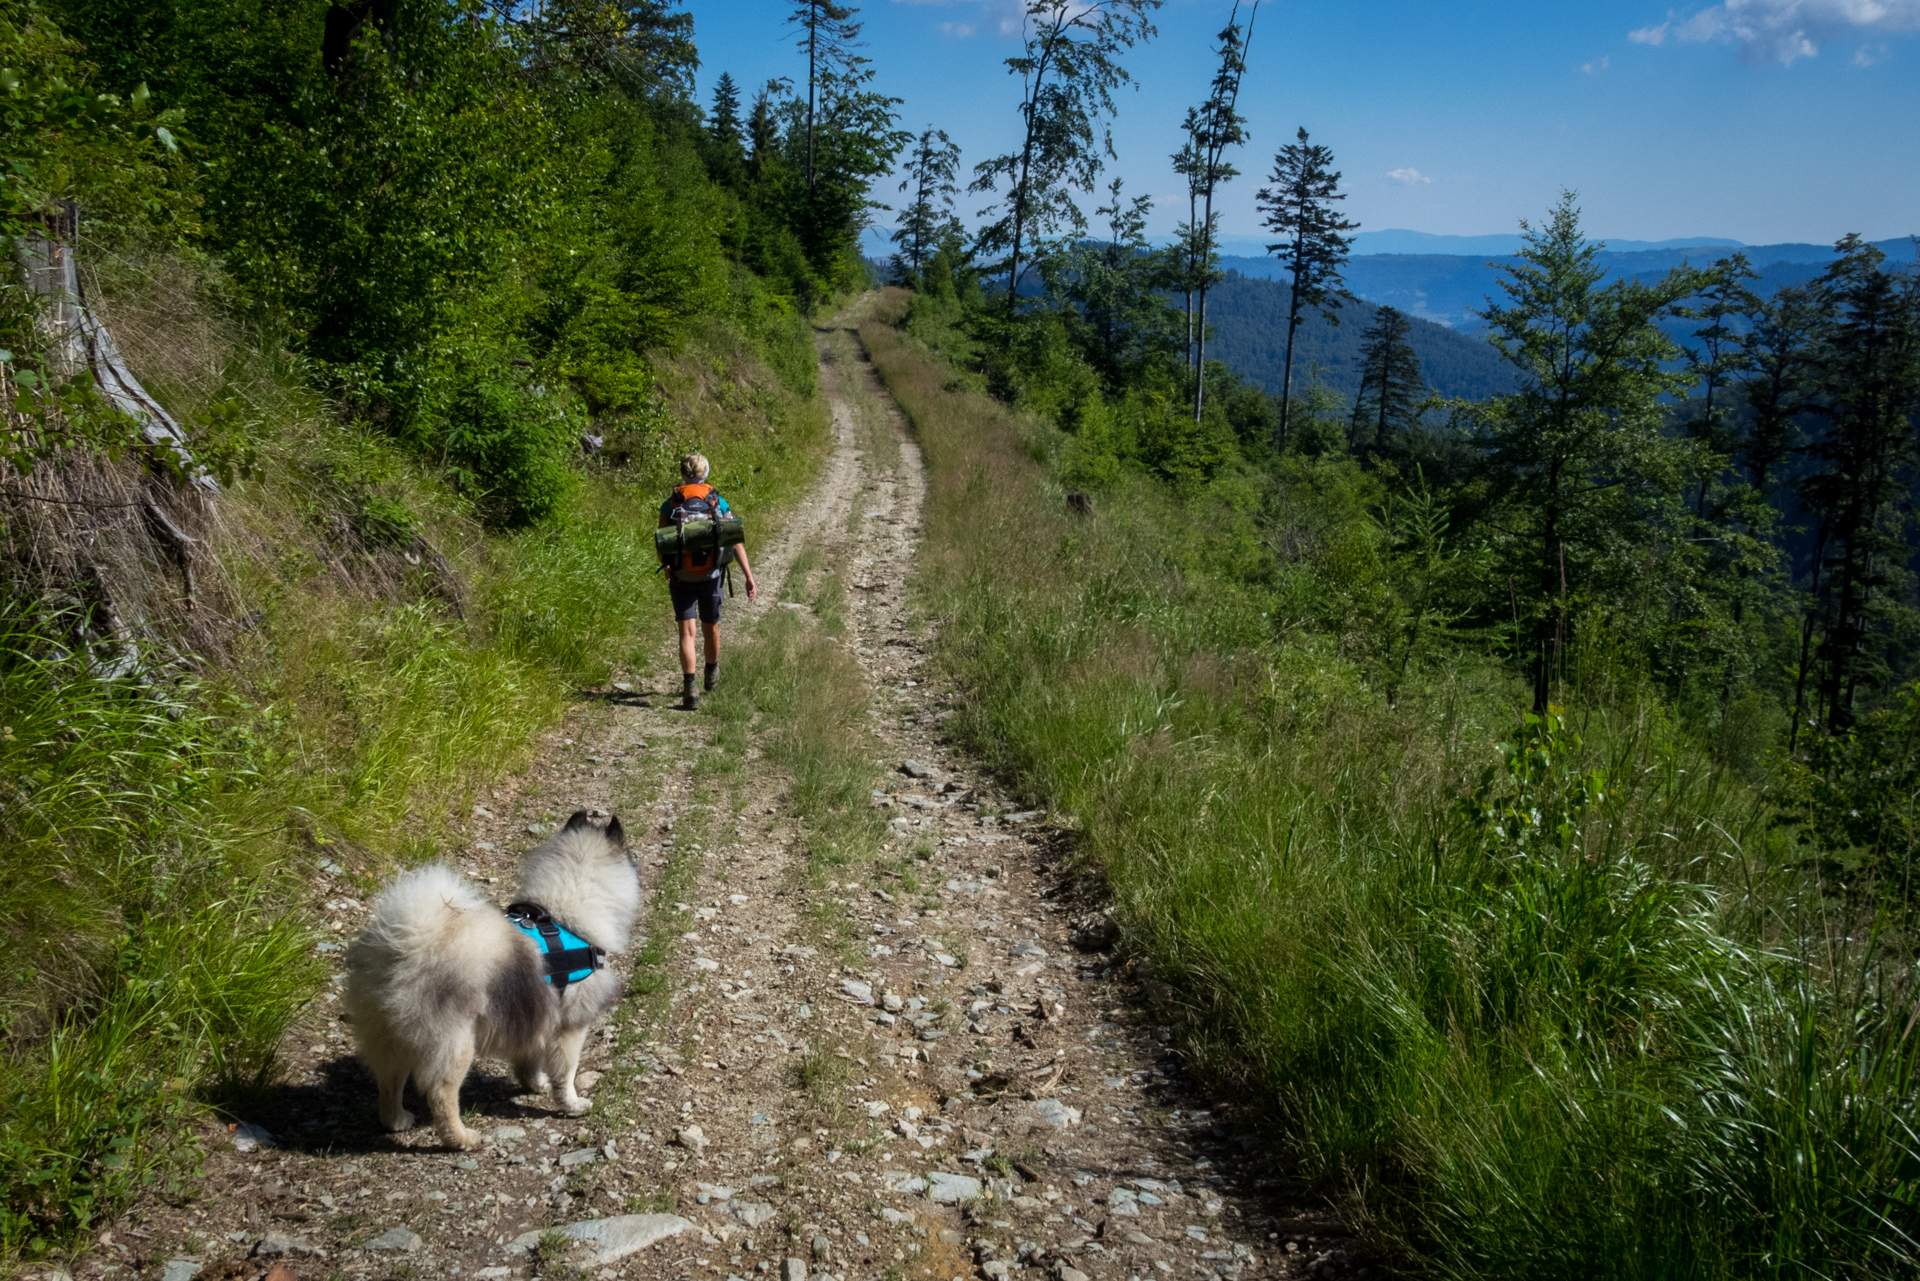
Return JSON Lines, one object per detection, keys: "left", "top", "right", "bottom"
{"left": 1258, "top": 129, "right": 1359, "bottom": 449}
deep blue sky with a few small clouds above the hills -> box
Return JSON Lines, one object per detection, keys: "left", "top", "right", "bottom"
{"left": 687, "top": 0, "right": 1920, "bottom": 244}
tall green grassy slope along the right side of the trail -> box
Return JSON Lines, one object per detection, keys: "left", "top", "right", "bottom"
{"left": 860, "top": 296, "right": 1920, "bottom": 1279}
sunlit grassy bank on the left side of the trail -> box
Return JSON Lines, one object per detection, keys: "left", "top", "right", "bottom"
{"left": 0, "top": 247, "right": 828, "bottom": 1256}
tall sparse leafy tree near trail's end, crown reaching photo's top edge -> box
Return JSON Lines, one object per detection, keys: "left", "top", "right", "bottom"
{"left": 968, "top": 0, "right": 1160, "bottom": 315}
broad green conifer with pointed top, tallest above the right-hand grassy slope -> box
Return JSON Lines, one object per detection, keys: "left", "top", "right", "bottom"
{"left": 1478, "top": 192, "right": 1703, "bottom": 714}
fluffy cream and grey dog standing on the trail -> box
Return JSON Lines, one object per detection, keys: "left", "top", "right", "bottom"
{"left": 346, "top": 810, "right": 639, "bottom": 1148}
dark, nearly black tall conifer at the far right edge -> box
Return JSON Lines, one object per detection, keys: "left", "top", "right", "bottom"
{"left": 1793, "top": 236, "right": 1920, "bottom": 734}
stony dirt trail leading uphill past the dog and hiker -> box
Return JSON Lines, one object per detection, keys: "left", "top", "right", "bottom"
{"left": 86, "top": 305, "right": 1367, "bottom": 1281}
